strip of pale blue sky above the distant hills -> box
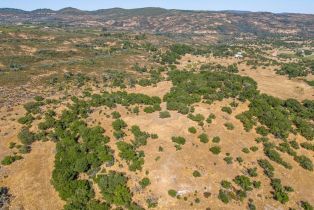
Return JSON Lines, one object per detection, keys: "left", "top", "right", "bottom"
{"left": 0, "top": 0, "right": 314, "bottom": 14}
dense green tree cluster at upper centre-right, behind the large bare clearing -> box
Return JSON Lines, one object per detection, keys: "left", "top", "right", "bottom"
{"left": 164, "top": 70, "right": 258, "bottom": 114}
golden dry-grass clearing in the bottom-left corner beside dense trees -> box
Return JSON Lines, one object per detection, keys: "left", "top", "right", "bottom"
{"left": 1, "top": 142, "right": 64, "bottom": 210}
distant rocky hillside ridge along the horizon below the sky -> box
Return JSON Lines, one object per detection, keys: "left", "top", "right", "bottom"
{"left": 0, "top": 8, "right": 314, "bottom": 37}
